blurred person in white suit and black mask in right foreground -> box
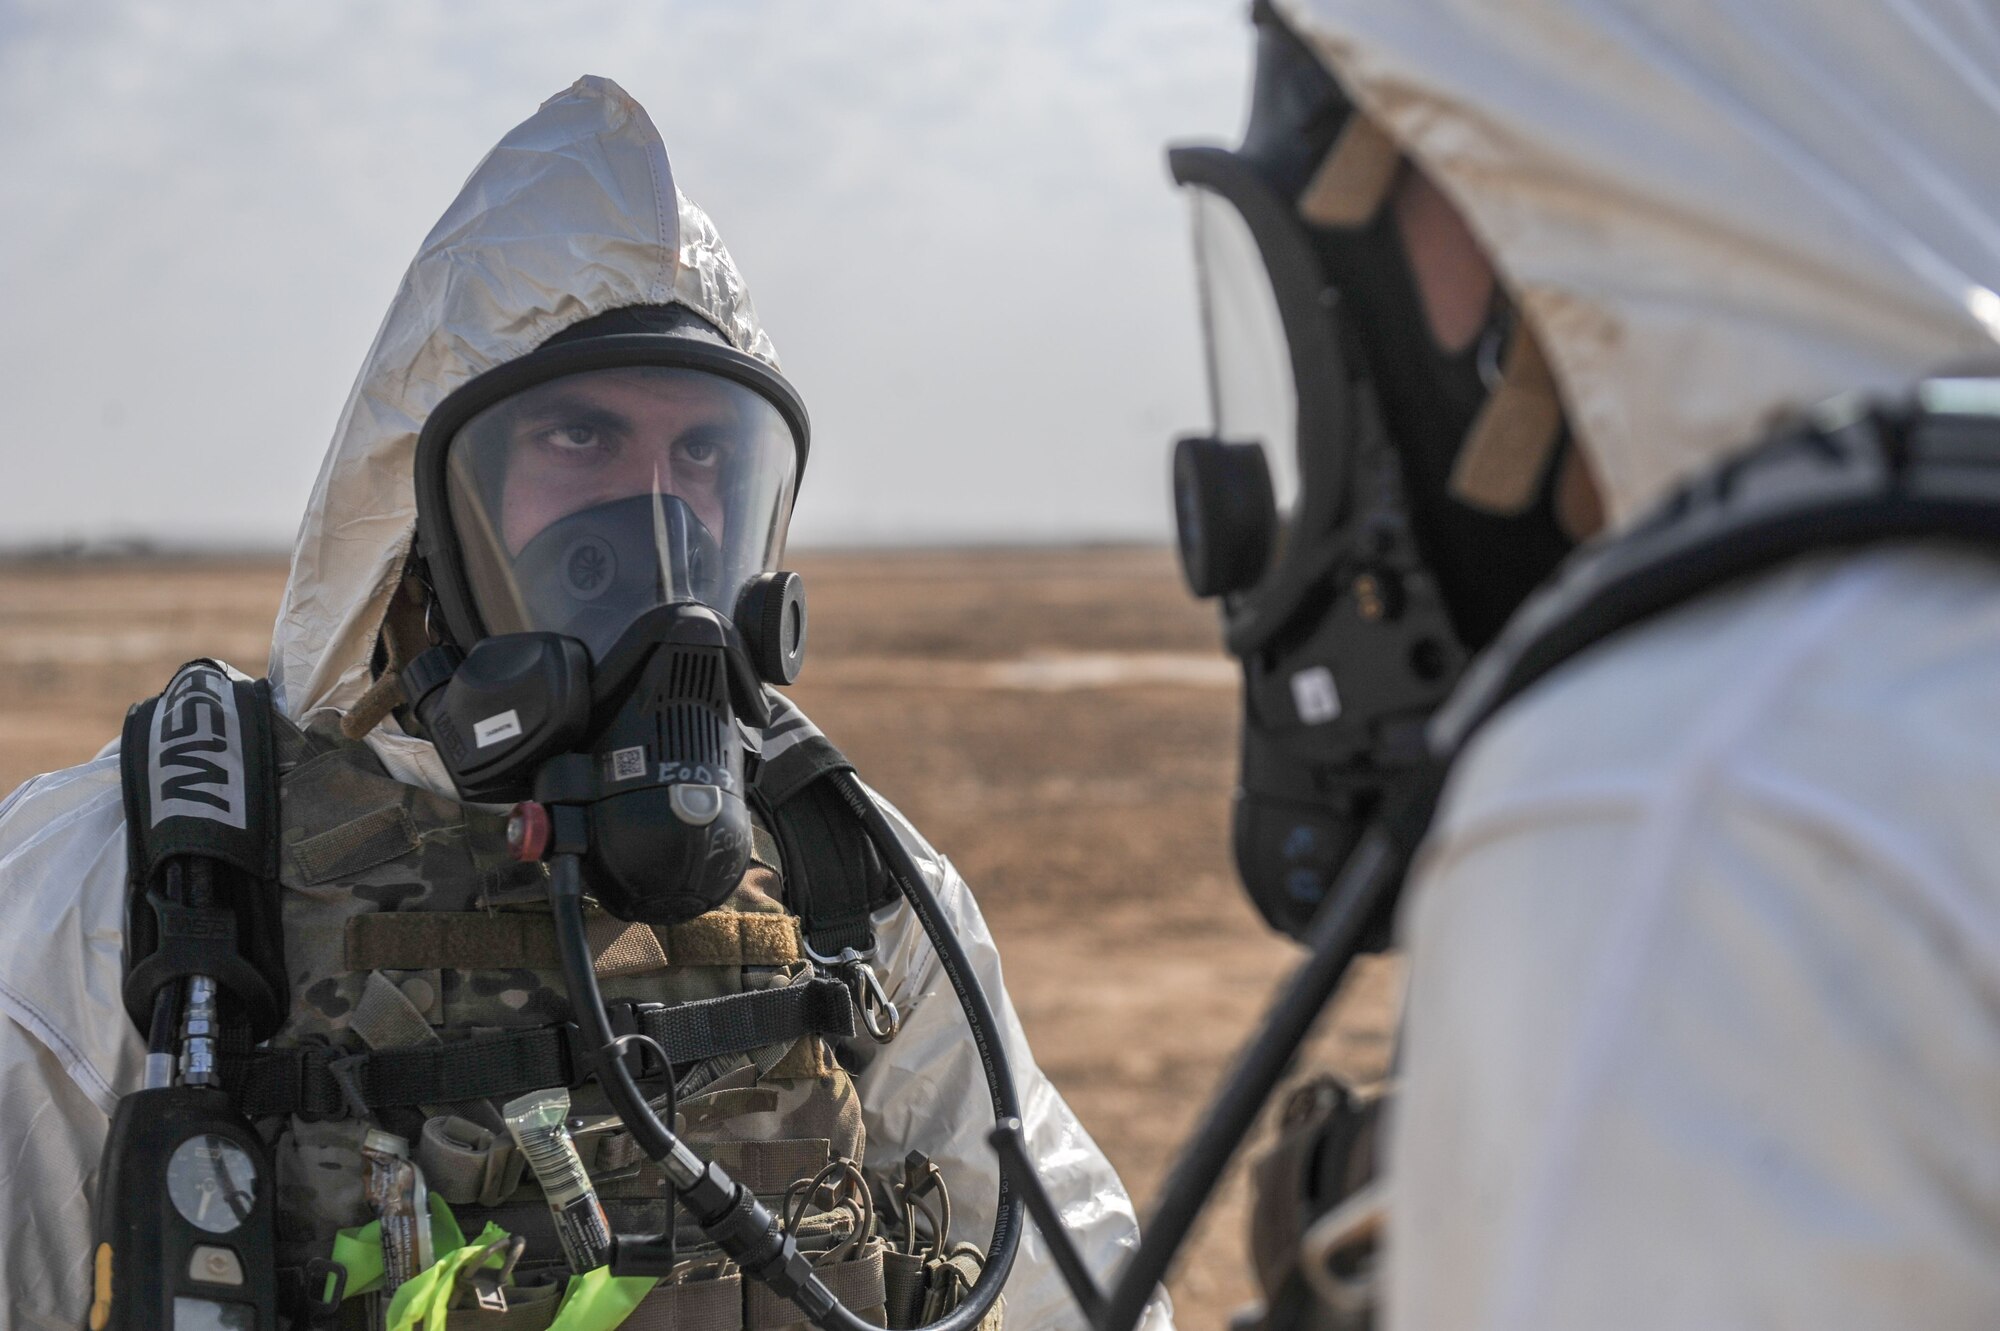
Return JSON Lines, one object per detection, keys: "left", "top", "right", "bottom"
{"left": 1174, "top": 0, "right": 2000, "bottom": 1331}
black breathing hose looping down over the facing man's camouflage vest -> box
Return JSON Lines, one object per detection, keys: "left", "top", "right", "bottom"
{"left": 548, "top": 771, "right": 1020, "bottom": 1331}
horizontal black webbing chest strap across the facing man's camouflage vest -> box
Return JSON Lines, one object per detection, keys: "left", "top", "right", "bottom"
{"left": 224, "top": 979, "right": 854, "bottom": 1119}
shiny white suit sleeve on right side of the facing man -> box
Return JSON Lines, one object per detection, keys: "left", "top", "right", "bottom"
{"left": 858, "top": 791, "right": 1172, "bottom": 1331}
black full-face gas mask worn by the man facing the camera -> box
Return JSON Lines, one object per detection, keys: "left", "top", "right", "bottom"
{"left": 404, "top": 306, "right": 808, "bottom": 923}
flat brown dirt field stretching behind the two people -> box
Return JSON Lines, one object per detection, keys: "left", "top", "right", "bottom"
{"left": 0, "top": 550, "right": 1394, "bottom": 1329}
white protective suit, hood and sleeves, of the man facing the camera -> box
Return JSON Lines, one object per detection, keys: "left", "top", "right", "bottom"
{"left": 0, "top": 78, "right": 1168, "bottom": 1331}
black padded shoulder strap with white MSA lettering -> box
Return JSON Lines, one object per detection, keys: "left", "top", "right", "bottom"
{"left": 120, "top": 658, "right": 290, "bottom": 1039}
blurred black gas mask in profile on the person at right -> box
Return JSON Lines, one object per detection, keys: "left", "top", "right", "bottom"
{"left": 1168, "top": 2, "right": 1572, "bottom": 937}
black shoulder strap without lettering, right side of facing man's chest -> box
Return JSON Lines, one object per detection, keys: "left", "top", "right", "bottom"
{"left": 756, "top": 693, "right": 896, "bottom": 957}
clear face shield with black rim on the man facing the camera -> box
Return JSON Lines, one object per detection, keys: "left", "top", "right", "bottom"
{"left": 416, "top": 320, "right": 806, "bottom": 662}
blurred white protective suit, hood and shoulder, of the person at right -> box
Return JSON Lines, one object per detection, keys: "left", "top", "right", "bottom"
{"left": 1284, "top": 0, "right": 2000, "bottom": 1331}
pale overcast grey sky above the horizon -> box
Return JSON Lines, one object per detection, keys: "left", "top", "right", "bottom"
{"left": 0, "top": 0, "right": 1250, "bottom": 546}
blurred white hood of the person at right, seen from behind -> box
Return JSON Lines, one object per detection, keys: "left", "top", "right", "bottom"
{"left": 1278, "top": 0, "right": 2000, "bottom": 522}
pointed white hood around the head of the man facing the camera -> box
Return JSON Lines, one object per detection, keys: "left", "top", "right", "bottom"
{"left": 270, "top": 78, "right": 778, "bottom": 793}
